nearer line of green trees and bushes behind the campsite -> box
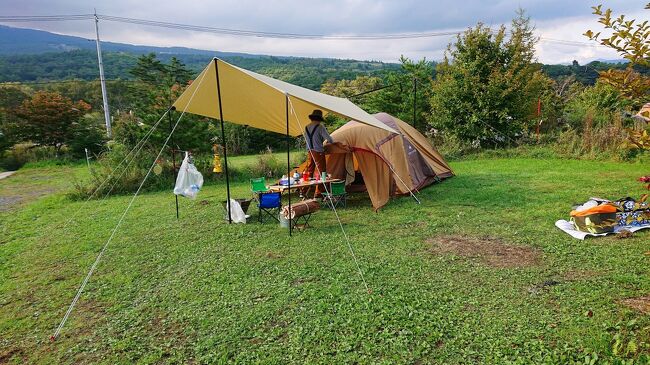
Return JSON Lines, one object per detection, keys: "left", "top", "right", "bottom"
{"left": 0, "top": 8, "right": 650, "bottom": 171}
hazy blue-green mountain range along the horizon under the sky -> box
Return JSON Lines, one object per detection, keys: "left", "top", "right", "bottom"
{"left": 0, "top": 25, "right": 636, "bottom": 90}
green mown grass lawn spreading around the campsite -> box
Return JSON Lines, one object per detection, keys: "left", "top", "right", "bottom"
{"left": 0, "top": 158, "right": 650, "bottom": 364}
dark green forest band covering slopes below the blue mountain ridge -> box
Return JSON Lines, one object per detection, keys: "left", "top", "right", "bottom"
{"left": 0, "top": 50, "right": 650, "bottom": 86}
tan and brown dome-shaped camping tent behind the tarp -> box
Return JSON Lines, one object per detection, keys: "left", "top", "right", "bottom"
{"left": 298, "top": 113, "right": 453, "bottom": 210}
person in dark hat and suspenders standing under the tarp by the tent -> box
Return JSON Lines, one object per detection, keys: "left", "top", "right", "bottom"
{"left": 305, "top": 109, "right": 334, "bottom": 198}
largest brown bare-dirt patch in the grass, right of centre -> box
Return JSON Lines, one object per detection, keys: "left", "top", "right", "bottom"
{"left": 426, "top": 235, "right": 541, "bottom": 268}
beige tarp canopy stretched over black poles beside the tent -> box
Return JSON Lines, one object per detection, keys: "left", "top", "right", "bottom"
{"left": 174, "top": 58, "right": 397, "bottom": 136}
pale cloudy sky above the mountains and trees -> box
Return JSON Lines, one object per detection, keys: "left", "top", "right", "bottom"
{"left": 0, "top": 0, "right": 650, "bottom": 63}
